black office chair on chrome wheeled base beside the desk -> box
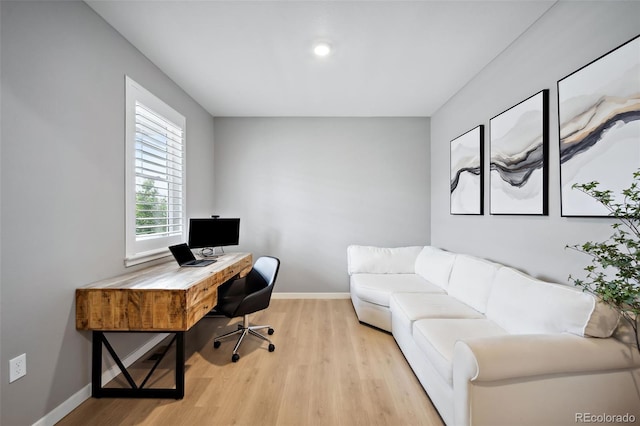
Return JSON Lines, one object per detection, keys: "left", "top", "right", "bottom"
{"left": 213, "top": 256, "right": 280, "bottom": 362}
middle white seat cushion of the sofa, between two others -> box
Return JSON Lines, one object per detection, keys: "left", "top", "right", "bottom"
{"left": 389, "top": 293, "right": 484, "bottom": 331}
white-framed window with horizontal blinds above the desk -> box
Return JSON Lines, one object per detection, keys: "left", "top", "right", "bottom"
{"left": 125, "top": 77, "right": 186, "bottom": 266}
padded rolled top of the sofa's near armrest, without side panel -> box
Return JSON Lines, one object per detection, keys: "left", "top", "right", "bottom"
{"left": 453, "top": 334, "right": 640, "bottom": 386}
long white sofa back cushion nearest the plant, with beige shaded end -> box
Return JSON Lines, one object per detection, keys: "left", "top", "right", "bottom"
{"left": 487, "top": 267, "right": 619, "bottom": 337}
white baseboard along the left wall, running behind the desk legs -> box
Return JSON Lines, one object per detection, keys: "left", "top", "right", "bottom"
{"left": 33, "top": 333, "right": 169, "bottom": 426}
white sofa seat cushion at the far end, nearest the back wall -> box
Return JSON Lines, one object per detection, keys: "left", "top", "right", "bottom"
{"left": 351, "top": 274, "right": 444, "bottom": 307}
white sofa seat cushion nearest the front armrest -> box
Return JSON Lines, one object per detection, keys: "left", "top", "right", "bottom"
{"left": 413, "top": 318, "right": 508, "bottom": 386}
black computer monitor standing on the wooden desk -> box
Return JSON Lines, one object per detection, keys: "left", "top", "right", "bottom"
{"left": 189, "top": 218, "right": 240, "bottom": 248}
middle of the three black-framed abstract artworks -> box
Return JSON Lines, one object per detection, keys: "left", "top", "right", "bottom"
{"left": 489, "top": 89, "right": 549, "bottom": 215}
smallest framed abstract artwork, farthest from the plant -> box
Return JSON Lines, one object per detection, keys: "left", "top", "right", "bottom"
{"left": 450, "top": 125, "right": 484, "bottom": 215}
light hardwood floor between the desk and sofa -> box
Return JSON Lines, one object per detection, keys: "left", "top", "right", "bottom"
{"left": 58, "top": 299, "right": 442, "bottom": 426}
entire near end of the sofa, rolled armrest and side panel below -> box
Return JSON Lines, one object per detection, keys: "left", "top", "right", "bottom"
{"left": 453, "top": 334, "right": 640, "bottom": 425}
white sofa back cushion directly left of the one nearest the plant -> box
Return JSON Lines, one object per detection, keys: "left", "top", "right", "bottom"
{"left": 447, "top": 254, "right": 502, "bottom": 313}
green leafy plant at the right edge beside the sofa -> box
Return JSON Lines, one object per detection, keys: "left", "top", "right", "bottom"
{"left": 566, "top": 171, "right": 640, "bottom": 351}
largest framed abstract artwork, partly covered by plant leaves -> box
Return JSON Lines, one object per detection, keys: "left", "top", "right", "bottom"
{"left": 558, "top": 36, "right": 640, "bottom": 216}
